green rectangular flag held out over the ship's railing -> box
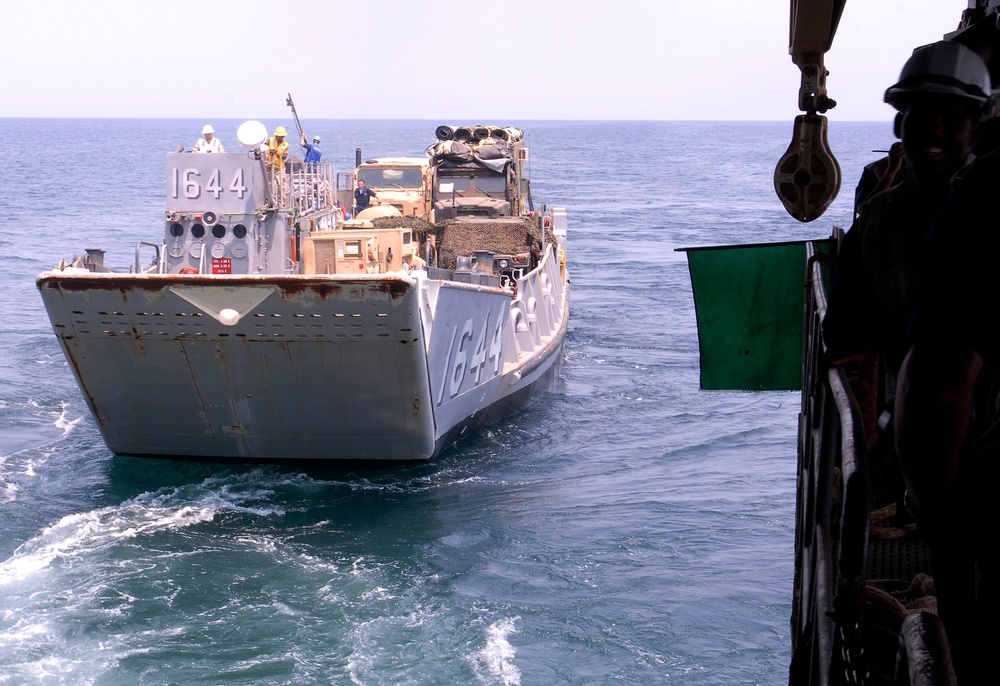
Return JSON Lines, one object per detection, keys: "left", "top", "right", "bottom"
{"left": 679, "top": 239, "right": 830, "bottom": 391}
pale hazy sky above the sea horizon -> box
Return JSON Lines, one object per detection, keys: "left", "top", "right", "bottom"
{"left": 0, "top": 0, "right": 967, "bottom": 121}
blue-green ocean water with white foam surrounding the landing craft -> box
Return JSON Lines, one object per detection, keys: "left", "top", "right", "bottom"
{"left": 0, "top": 119, "right": 892, "bottom": 686}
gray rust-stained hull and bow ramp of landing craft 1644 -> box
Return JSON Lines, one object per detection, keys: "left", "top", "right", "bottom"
{"left": 38, "top": 250, "right": 569, "bottom": 462}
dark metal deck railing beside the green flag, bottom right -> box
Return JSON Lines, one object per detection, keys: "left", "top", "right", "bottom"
{"left": 789, "top": 235, "right": 871, "bottom": 684}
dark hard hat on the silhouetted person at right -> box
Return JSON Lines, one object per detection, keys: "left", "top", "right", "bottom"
{"left": 885, "top": 41, "right": 992, "bottom": 111}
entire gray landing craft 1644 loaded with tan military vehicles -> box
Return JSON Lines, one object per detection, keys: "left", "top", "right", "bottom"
{"left": 37, "top": 122, "right": 569, "bottom": 462}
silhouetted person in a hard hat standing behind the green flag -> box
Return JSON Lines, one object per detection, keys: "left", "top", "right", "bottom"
{"left": 823, "top": 41, "right": 991, "bottom": 484}
